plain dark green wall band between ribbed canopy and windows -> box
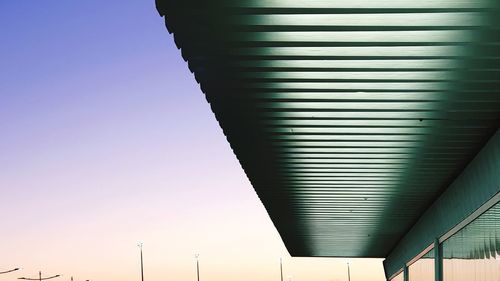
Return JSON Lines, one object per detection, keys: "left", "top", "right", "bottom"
{"left": 384, "top": 130, "right": 500, "bottom": 279}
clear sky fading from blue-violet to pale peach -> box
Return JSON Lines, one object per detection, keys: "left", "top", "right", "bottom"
{"left": 0, "top": 0, "right": 385, "bottom": 281}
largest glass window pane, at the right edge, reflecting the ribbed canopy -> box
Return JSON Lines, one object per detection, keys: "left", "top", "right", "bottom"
{"left": 443, "top": 203, "right": 500, "bottom": 281}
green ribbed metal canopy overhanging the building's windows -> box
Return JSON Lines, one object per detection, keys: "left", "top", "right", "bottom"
{"left": 156, "top": 0, "right": 500, "bottom": 257}
